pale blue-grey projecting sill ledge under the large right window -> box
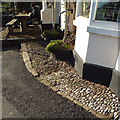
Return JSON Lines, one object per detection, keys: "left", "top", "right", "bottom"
{"left": 87, "top": 26, "right": 120, "bottom": 38}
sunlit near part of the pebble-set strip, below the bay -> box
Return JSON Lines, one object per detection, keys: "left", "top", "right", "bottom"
{"left": 45, "top": 71, "right": 120, "bottom": 116}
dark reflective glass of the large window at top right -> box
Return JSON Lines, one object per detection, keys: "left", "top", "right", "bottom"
{"left": 95, "top": 2, "right": 120, "bottom": 22}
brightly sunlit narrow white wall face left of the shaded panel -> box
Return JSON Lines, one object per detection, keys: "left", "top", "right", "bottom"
{"left": 73, "top": 16, "right": 89, "bottom": 62}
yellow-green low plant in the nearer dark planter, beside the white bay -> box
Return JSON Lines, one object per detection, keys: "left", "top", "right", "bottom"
{"left": 45, "top": 40, "right": 69, "bottom": 52}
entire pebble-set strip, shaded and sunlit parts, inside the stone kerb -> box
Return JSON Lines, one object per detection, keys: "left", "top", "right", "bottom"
{"left": 26, "top": 40, "right": 120, "bottom": 118}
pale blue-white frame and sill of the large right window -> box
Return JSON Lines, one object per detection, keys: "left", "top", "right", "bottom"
{"left": 87, "top": 0, "right": 120, "bottom": 38}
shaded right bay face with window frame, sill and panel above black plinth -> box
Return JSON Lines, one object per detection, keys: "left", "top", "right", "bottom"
{"left": 86, "top": 2, "right": 120, "bottom": 68}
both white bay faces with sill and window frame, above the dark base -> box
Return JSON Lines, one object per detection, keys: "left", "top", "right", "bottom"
{"left": 74, "top": 1, "right": 120, "bottom": 69}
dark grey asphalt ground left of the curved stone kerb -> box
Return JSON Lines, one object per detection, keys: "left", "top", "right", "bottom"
{"left": 2, "top": 45, "right": 98, "bottom": 118}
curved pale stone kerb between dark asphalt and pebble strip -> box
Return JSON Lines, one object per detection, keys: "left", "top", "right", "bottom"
{"left": 21, "top": 43, "right": 110, "bottom": 119}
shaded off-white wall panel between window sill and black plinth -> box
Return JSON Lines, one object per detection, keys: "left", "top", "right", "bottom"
{"left": 86, "top": 34, "right": 118, "bottom": 68}
